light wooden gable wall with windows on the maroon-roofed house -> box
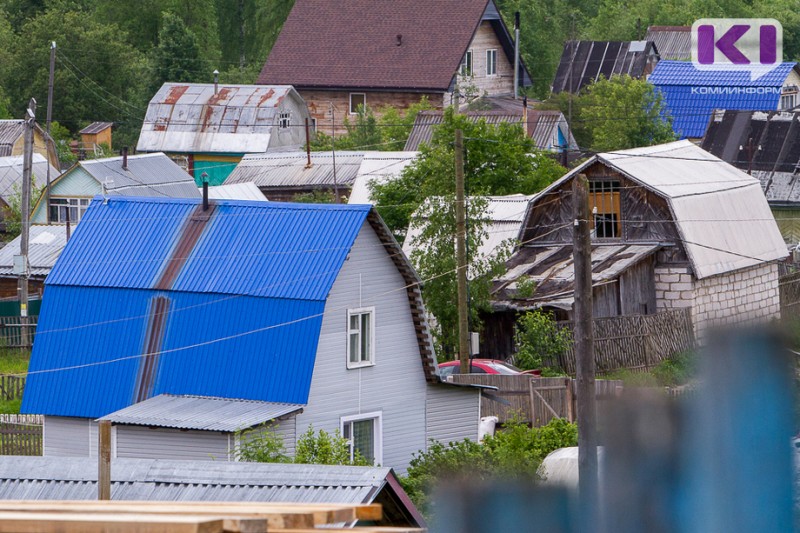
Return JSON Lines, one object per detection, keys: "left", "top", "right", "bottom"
{"left": 458, "top": 20, "right": 514, "bottom": 96}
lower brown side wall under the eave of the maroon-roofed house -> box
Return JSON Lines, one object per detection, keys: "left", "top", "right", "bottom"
{"left": 297, "top": 89, "right": 449, "bottom": 136}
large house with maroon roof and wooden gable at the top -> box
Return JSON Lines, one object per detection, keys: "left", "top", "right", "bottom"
{"left": 257, "top": 0, "right": 530, "bottom": 133}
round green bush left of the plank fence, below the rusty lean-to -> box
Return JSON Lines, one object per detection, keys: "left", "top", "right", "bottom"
{"left": 514, "top": 309, "right": 572, "bottom": 370}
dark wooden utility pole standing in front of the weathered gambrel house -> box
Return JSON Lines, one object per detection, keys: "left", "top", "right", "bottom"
{"left": 572, "top": 174, "right": 598, "bottom": 523}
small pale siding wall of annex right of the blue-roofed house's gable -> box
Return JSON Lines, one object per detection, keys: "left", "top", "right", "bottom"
{"left": 425, "top": 385, "right": 481, "bottom": 444}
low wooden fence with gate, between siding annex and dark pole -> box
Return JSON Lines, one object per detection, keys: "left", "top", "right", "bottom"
{"left": 448, "top": 374, "right": 622, "bottom": 427}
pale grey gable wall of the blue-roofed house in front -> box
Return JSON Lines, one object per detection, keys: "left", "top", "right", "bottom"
{"left": 297, "top": 218, "right": 426, "bottom": 472}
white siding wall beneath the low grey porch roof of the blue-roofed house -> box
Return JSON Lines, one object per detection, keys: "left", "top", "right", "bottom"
{"left": 116, "top": 425, "right": 229, "bottom": 461}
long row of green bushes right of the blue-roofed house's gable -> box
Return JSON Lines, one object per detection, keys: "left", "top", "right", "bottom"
{"left": 401, "top": 418, "right": 578, "bottom": 516}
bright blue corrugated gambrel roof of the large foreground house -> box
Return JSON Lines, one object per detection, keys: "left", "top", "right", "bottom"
{"left": 22, "top": 198, "right": 369, "bottom": 418}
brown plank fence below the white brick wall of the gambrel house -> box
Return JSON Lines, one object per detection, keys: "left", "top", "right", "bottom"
{"left": 551, "top": 309, "right": 695, "bottom": 375}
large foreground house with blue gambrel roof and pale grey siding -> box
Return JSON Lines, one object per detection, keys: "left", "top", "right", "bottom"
{"left": 22, "top": 196, "right": 480, "bottom": 471}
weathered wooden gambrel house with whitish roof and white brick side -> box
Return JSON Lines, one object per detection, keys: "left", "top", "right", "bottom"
{"left": 487, "top": 141, "right": 788, "bottom": 355}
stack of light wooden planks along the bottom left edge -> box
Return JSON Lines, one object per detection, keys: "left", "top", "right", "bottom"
{"left": 0, "top": 500, "right": 424, "bottom": 533}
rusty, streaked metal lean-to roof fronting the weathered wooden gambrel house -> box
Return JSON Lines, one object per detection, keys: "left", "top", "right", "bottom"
{"left": 492, "top": 244, "right": 660, "bottom": 309}
